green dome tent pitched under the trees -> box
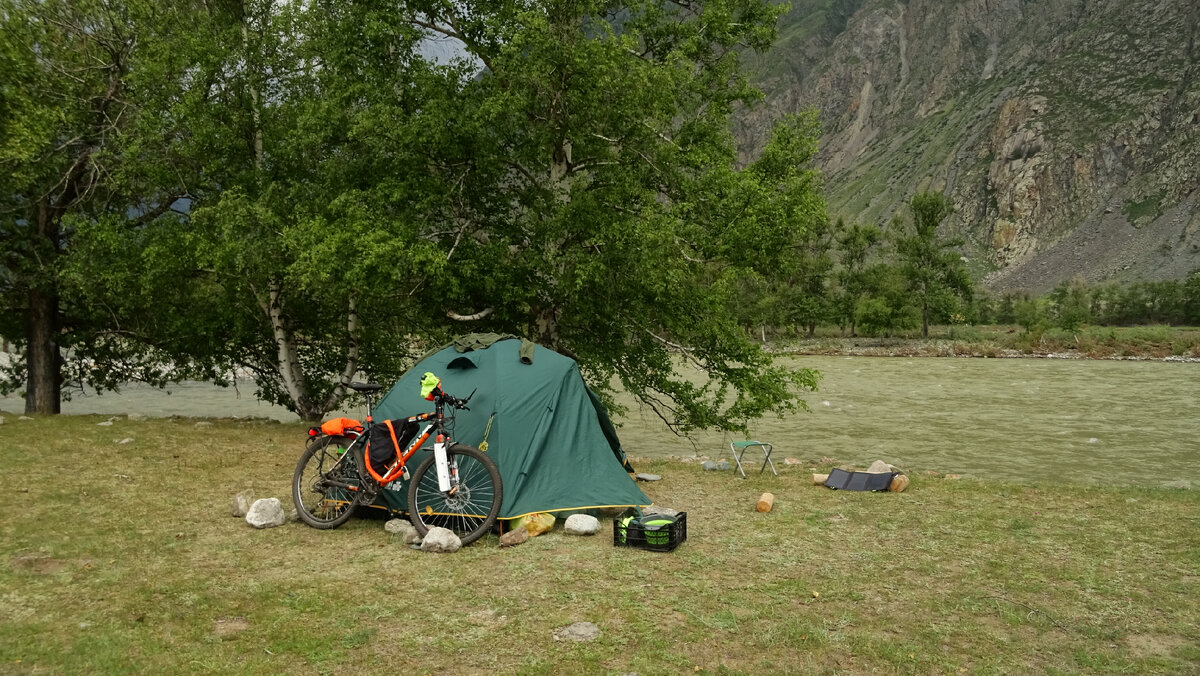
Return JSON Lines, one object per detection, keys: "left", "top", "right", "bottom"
{"left": 374, "top": 334, "right": 650, "bottom": 519}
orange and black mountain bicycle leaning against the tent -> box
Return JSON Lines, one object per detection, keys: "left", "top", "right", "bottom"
{"left": 292, "top": 373, "right": 504, "bottom": 545}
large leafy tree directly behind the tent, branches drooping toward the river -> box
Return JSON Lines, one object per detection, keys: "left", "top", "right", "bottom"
{"left": 385, "top": 0, "right": 824, "bottom": 431}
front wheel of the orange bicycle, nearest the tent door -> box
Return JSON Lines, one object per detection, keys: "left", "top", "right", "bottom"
{"left": 408, "top": 444, "right": 504, "bottom": 545}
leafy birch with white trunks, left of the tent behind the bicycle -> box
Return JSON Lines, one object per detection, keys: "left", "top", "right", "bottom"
{"left": 65, "top": 0, "right": 448, "bottom": 420}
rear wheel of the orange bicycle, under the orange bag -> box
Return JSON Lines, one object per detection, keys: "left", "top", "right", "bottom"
{"left": 292, "top": 437, "right": 362, "bottom": 530}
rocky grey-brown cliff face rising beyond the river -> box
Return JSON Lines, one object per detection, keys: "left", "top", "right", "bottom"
{"left": 739, "top": 0, "right": 1200, "bottom": 291}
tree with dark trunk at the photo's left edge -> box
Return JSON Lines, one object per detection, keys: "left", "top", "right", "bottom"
{"left": 0, "top": 0, "right": 189, "bottom": 414}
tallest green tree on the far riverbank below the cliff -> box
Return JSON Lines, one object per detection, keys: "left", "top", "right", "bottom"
{"left": 892, "top": 192, "right": 973, "bottom": 337}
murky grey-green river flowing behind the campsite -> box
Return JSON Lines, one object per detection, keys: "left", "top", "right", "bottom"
{"left": 0, "top": 357, "right": 1200, "bottom": 487}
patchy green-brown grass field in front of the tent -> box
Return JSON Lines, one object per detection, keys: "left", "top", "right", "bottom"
{"left": 0, "top": 415, "right": 1200, "bottom": 675}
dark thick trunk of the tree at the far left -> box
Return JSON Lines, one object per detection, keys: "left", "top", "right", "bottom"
{"left": 25, "top": 201, "right": 62, "bottom": 415}
